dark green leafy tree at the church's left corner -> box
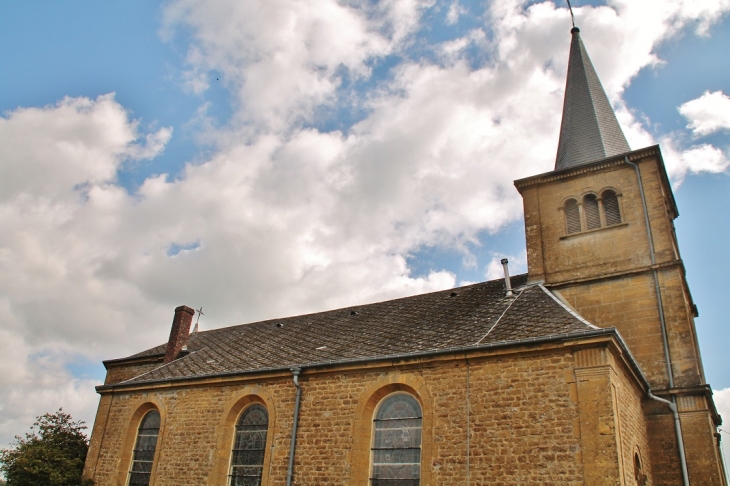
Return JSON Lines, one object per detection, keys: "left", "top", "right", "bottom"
{"left": 0, "top": 408, "right": 89, "bottom": 486}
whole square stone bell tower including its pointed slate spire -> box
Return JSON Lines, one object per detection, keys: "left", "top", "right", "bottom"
{"left": 515, "top": 27, "right": 726, "bottom": 485}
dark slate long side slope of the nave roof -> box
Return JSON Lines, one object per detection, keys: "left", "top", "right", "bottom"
{"left": 115, "top": 275, "right": 594, "bottom": 383}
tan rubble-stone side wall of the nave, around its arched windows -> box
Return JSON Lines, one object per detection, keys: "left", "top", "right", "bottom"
{"left": 85, "top": 349, "right": 643, "bottom": 486}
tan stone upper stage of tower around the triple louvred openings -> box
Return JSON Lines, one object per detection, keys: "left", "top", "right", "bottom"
{"left": 521, "top": 158, "right": 679, "bottom": 284}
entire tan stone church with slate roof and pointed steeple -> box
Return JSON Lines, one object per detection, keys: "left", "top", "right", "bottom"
{"left": 84, "top": 27, "right": 727, "bottom": 486}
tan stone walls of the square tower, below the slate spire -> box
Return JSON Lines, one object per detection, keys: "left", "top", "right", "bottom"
{"left": 516, "top": 147, "right": 724, "bottom": 484}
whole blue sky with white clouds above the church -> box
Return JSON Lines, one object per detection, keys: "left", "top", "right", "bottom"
{"left": 0, "top": 0, "right": 730, "bottom": 456}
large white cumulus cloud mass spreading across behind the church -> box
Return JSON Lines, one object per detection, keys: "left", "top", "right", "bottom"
{"left": 0, "top": 0, "right": 726, "bottom": 448}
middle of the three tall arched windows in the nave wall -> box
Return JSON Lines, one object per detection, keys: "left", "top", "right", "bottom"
{"left": 230, "top": 403, "right": 269, "bottom": 486}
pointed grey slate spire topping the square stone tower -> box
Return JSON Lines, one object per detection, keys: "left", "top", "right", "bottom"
{"left": 555, "top": 27, "right": 631, "bottom": 170}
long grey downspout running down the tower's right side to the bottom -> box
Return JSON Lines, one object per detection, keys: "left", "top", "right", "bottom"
{"left": 624, "top": 157, "right": 689, "bottom": 486}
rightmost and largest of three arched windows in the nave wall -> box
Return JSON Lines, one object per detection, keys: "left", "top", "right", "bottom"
{"left": 370, "top": 393, "right": 423, "bottom": 486}
